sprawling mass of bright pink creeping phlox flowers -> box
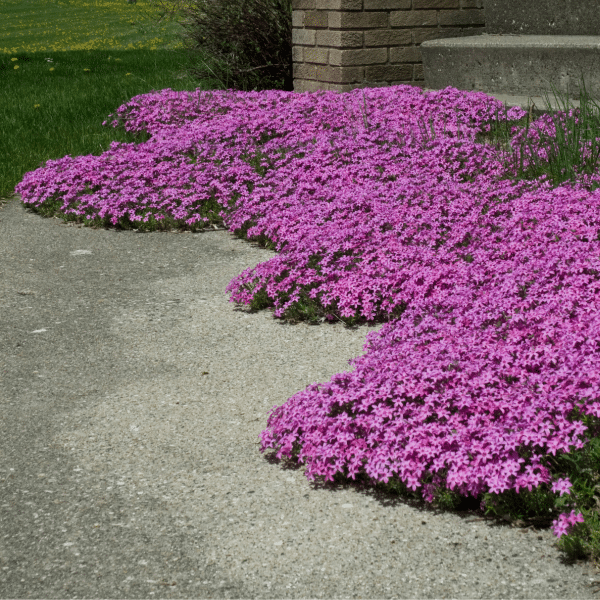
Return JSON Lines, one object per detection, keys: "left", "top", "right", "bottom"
{"left": 17, "top": 86, "right": 600, "bottom": 531}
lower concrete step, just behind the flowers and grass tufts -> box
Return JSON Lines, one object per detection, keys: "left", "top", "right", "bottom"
{"left": 421, "top": 34, "right": 600, "bottom": 99}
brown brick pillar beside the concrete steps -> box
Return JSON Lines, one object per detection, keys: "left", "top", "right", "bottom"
{"left": 292, "top": 0, "right": 484, "bottom": 92}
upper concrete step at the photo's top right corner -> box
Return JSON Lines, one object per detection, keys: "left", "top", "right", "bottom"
{"left": 484, "top": 0, "right": 600, "bottom": 35}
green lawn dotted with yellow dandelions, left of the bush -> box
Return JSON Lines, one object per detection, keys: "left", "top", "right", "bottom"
{"left": 0, "top": 0, "right": 214, "bottom": 198}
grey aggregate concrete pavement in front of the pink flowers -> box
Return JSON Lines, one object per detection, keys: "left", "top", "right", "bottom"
{"left": 0, "top": 195, "right": 597, "bottom": 598}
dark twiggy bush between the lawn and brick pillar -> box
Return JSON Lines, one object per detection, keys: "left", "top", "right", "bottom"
{"left": 176, "top": 0, "right": 294, "bottom": 91}
